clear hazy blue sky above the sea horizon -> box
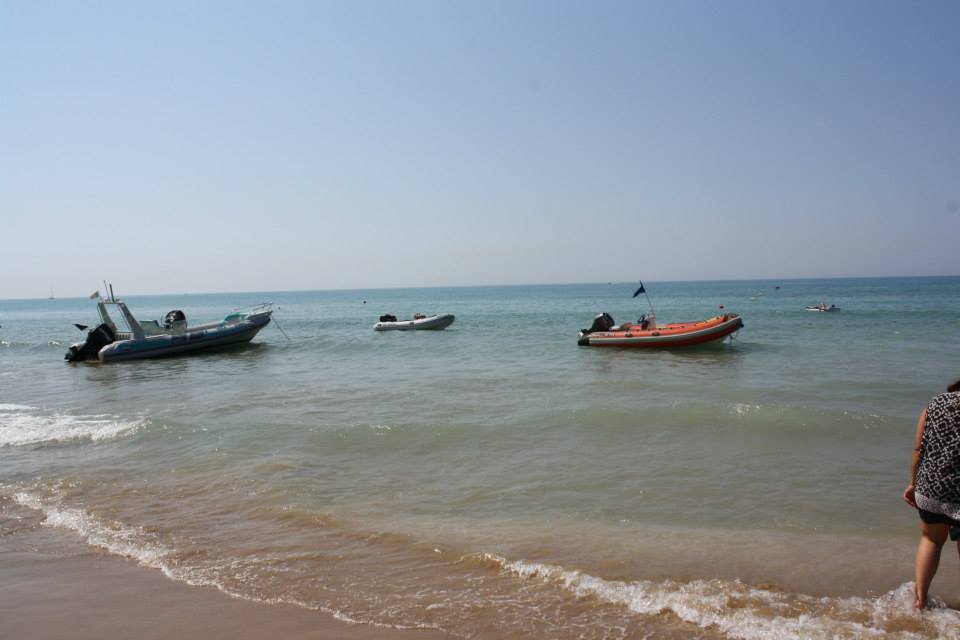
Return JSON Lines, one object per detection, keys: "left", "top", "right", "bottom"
{"left": 0, "top": 0, "right": 960, "bottom": 298}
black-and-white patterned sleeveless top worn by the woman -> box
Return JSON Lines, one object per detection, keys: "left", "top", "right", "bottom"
{"left": 916, "top": 392, "right": 960, "bottom": 520}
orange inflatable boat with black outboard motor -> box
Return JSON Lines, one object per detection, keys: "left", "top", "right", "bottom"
{"left": 577, "top": 313, "right": 743, "bottom": 348}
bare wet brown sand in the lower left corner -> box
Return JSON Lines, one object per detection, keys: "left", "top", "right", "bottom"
{"left": 0, "top": 532, "right": 449, "bottom": 640}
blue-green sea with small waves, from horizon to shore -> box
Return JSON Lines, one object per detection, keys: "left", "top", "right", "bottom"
{"left": 0, "top": 278, "right": 960, "bottom": 638}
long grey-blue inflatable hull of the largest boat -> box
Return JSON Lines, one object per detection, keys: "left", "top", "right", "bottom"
{"left": 97, "top": 311, "right": 270, "bottom": 362}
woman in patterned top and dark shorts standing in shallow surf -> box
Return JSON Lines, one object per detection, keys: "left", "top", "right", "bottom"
{"left": 903, "top": 380, "right": 960, "bottom": 609}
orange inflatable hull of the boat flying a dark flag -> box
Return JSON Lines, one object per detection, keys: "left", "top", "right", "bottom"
{"left": 577, "top": 314, "right": 743, "bottom": 349}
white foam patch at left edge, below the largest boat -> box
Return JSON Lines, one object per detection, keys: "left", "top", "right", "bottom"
{"left": 0, "top": 404, "right": 149, "bottom": 447}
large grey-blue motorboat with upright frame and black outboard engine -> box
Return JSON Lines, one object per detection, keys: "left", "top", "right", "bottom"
{"left": 64, "top": 287, "right": 273, "bottom": 362}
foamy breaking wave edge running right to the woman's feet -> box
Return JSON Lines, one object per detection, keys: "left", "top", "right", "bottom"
{"left": 482, "top": 554, "right": 960, "bottom": 640}
